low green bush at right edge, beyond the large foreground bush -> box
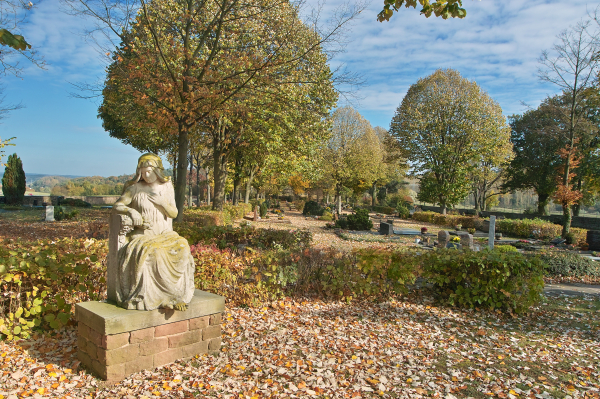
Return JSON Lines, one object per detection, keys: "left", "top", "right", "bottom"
{"left": 531, "top": 251, "right": 600, "bottom": 277}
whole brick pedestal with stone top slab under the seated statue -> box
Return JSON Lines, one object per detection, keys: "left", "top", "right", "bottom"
{"left": 76, "top": 290, "right": 225, "bottom": 381}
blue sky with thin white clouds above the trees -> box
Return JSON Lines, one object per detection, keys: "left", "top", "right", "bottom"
{"left": 0, "top": 0, "right": 598, "bottom": 176}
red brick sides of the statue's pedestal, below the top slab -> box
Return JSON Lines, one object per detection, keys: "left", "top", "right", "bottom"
{"left": 77, "top": 313, "right": 221, "bottom": 381}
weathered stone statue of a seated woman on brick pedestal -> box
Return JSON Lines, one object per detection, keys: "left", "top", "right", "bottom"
{"left": 107, "top": 154, "right": 195, "bottom": 310}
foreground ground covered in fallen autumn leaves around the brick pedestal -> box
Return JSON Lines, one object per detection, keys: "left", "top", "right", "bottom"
{"left": 0, "top": 298, "right": 600, "bottom": 398}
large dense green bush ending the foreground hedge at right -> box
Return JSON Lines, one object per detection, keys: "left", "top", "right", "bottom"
{"left": 413, "top": 250, "right": 544, "bottom": 313}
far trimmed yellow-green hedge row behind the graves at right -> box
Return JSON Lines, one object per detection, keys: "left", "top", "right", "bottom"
{"left": 413, "top": 211, "right": 587, "bottom": 245}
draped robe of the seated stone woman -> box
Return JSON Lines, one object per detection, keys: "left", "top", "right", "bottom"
{"left": 117, "top": 181, "right": 195, "bottom": 310}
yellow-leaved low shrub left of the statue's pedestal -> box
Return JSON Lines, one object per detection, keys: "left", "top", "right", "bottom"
{"left": 0, "top": 238, "right": 108, "bottom": 340}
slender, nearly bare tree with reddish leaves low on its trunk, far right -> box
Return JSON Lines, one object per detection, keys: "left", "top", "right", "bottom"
{"left": 538, "top": 21, "right": 600, "bottom": 237}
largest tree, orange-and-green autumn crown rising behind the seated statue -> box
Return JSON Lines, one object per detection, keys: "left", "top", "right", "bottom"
{"left": 92, "top": 0, "right": 346, "bottom": 218}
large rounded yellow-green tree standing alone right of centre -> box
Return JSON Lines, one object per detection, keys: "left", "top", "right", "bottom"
{"left": 390, "top": 69, "right": 510, "bottom": 213}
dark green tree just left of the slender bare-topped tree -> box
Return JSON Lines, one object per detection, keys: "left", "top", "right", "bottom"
{"left": 503, "top": 98, "right": 565, "bottom": 215}
